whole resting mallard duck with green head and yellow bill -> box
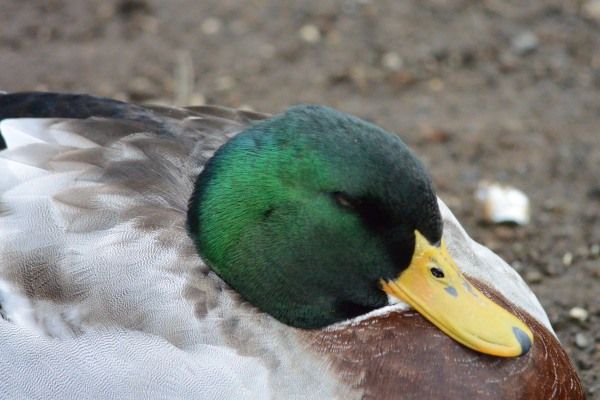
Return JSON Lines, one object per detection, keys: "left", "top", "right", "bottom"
{"left": 0, "top": 92, "right": 585, "bottom": 400}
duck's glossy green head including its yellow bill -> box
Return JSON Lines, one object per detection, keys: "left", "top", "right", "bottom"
{"left": 188, "top": 106, "right": 533, "bottom": 356}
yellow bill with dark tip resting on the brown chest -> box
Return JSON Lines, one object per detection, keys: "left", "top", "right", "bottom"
{"left": 382, "top": 231, "right": 533, "bottom": 357}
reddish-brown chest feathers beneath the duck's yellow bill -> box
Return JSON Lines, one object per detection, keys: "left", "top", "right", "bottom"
{"left": 309, "top": 282, "right": 585, "bottom": 400}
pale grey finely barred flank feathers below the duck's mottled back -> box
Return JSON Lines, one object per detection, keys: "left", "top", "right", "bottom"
{"left": 0, "top": 320, "right": 268, "bottom": 399}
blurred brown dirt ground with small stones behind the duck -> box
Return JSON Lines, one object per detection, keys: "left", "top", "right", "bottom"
{"left": 0, "top": 0, "right": 600, "bottom": 398}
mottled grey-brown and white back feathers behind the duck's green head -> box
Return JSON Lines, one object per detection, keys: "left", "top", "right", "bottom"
{"left": 0, "top": 94, "right": 258, "bottom": 340}
